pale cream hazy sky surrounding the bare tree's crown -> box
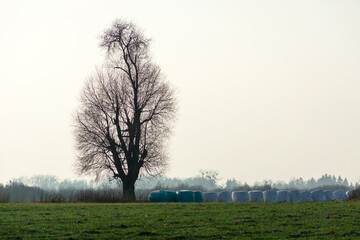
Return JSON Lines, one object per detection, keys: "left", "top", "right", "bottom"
{"left": 0, "top": 0, "right": 360, "bottom": 183}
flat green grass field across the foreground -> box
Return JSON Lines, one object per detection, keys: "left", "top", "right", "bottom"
{"left": 0, "top": 202, "right": 360, "bottom": 239}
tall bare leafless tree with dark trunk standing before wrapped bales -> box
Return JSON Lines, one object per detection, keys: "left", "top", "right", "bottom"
{"left": 74, "top": 20, "right": 176, "bottom": 201}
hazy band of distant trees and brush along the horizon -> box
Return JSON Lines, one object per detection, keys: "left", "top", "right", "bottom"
{"left": 0, "top": 170, "right": 359, "bottom": 202}
